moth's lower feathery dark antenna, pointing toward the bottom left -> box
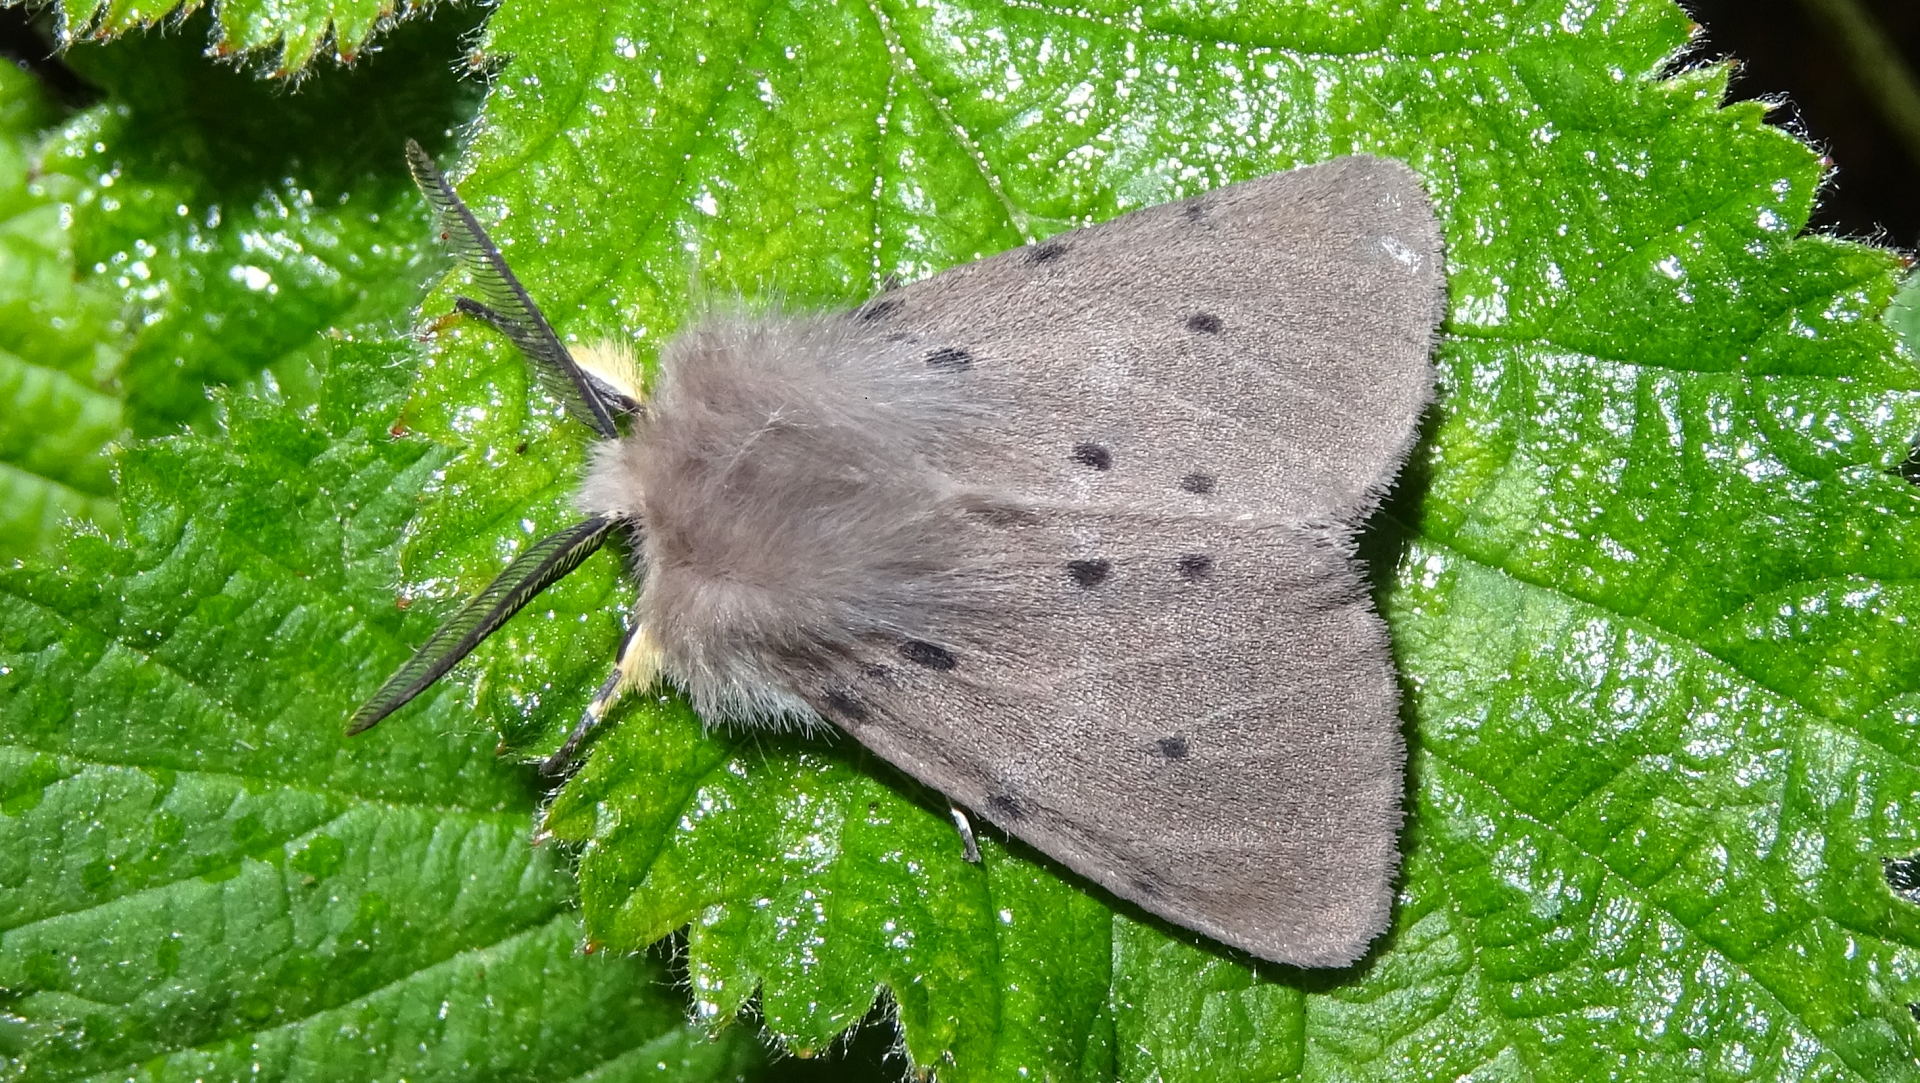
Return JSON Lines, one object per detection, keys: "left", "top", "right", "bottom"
{"left": 348, "top": 515, "right": 618, "bottom": 735}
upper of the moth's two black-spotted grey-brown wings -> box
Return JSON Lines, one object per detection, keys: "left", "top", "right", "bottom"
{"left": 871, "top": 157, "right": 1446, "bottom": 522}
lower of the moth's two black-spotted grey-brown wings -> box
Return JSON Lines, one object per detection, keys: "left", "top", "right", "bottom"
{"left": 814, "top": 511, "right": 1405, "bottom": 966}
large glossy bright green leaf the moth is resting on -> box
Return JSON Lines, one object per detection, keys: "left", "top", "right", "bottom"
{"left": 378, "top": 0, "right": 1920, "bottom": 1079}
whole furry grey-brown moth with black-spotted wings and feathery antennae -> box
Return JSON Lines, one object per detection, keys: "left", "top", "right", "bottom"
{"left": 351, "top": 144, "right": 1444, "bottom": 966}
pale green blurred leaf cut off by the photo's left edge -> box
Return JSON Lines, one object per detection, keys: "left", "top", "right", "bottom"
{"left": 0, "top": 65, "right": 125, "bottom": 559}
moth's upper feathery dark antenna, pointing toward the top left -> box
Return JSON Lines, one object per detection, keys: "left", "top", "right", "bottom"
{"left": 407, "top": 138, "right": 639, "bottom": 440}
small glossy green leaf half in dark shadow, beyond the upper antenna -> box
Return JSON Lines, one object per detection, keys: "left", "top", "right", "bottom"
{"left": 42, "top": 6, "right": 480, "bottom": 436}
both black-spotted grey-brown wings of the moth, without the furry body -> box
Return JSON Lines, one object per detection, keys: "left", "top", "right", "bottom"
{"left": 816, "top": 157, "right": 1444, "bottom": 966}
